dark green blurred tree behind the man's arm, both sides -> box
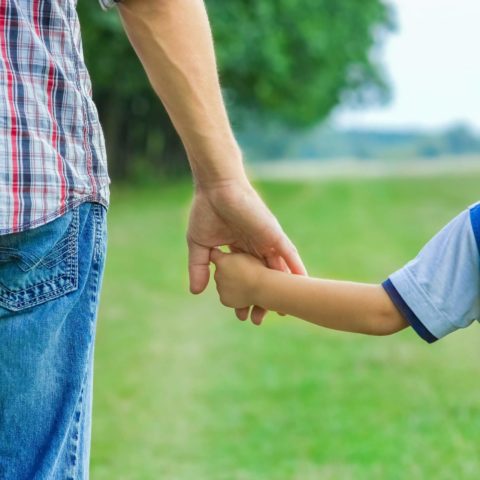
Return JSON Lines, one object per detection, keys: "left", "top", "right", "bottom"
{"left": 78, "top": 0, "right": 393, "bottom": 177}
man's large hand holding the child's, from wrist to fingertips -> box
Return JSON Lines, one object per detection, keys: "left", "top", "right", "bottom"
{"left": 187, "top": 180, "right": 306, "bottom": 325}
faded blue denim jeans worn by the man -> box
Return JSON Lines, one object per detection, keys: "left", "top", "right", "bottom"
{"left": 0, "top": 202, "right": 107, "bottom": 480}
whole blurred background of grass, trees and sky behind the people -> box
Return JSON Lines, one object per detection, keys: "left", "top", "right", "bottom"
{"left": 78, "top": 0, "right": 480, "bottom": 480}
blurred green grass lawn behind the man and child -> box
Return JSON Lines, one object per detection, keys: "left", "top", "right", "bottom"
{"left": 92, "top": 175, "right": 480, "bottom": 480}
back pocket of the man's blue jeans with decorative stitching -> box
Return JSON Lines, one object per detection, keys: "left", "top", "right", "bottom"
{"left": 0, "top": 207, "right": 79, "bottom": 311}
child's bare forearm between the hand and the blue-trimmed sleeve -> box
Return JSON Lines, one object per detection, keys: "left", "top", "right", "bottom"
{"left": 254, "top": 269, "right": 407, "bottom": 335}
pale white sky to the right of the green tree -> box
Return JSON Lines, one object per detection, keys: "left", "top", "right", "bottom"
{"left": 333, "top": 0, "right": 480, "bottom": 132}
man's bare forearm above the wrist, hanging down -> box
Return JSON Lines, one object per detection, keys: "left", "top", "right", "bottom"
{"left": 115, "top": 0, "right": 245, "bottom": 185}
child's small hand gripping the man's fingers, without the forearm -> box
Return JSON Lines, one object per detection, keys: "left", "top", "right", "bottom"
{"left": 210, "top": 248, "right": 267, "bottom": 308}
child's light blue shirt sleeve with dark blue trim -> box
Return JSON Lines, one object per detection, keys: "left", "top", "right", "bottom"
{"left": 382, "top": 203, "right": 480, "bottom": 343}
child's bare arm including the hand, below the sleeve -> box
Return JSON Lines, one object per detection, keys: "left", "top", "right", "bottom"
{"left": 211, "top": 250, "right": 408, "bottom": 335}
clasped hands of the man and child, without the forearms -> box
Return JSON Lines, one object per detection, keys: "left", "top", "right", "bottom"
{"left": 187, "top": 180, "right": 306, "bottom": 325}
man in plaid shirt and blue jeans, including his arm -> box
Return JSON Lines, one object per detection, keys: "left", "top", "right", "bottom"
{"left": 0, "top": 0, "right": 305, "bottom": 480}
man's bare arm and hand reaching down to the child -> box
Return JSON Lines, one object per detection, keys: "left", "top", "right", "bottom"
{"left": 114, "top": 0, "right": 306, "bottom": 323}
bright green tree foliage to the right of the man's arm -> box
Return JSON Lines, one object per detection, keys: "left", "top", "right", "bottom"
{"left": 207, "top": 0, "right": 393, "bottom": 126}
